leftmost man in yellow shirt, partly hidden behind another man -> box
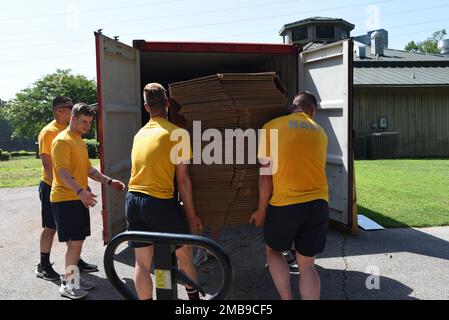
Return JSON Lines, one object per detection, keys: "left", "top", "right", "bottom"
{"left": 35, "top": 96, "right": 97, "bottom": 281}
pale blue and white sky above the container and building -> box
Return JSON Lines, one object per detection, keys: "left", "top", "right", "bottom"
{"left": 0, "top": 0, "right": 449, "bottom": 100}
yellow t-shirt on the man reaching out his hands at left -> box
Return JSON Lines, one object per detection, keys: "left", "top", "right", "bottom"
{"left": 50, "top": 129, "right": 92, "bottom": 202}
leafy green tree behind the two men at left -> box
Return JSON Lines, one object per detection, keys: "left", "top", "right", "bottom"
{"left": 4, "top": 69, "right": 97, "bottom": 139}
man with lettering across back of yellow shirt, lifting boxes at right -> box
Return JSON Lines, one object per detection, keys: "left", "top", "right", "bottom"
{"left": 251, "top": 92, "right": 329, "bottom": 300}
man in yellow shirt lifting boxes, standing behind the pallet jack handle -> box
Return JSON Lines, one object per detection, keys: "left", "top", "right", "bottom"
{"left": 126, "top": 83, "right": 202, "bottom": 300}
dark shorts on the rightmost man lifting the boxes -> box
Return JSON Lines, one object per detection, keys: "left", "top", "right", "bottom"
{"left": 264, "top": 200, "right": 329, "bottom": 257}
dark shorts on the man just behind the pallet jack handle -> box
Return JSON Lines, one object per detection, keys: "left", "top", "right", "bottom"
{"left": 126, "top": 192, "right": 190, "bottom": 248}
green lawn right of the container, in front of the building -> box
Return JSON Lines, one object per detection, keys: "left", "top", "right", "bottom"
{"left": 355, "top": 160, "right": 449, "bottom": 228}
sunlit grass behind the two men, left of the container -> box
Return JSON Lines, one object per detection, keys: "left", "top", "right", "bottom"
{"left": 0, "top": 157, "right": 100, "bottom": 188}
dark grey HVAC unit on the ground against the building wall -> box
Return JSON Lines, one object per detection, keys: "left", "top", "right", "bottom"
{"left": 368, "top": 132, "right": 399, "bottom": 160}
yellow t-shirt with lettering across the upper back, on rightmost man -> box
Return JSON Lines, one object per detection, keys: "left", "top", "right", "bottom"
{"left": 258, "top": 112, "right": 329, "bottom": 207}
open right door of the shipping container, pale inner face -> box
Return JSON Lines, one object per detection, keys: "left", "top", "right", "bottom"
{"left": 298, "top": 40, "right": 357, "bottom": 233}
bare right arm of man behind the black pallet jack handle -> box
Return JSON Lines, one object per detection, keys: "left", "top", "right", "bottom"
{"left": 176, "top": 164, "right": 203, "bottom": 233}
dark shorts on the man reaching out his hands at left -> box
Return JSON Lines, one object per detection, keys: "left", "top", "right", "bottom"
{"left": 51, "top": 200, "right": 90, "bottom": 242}
